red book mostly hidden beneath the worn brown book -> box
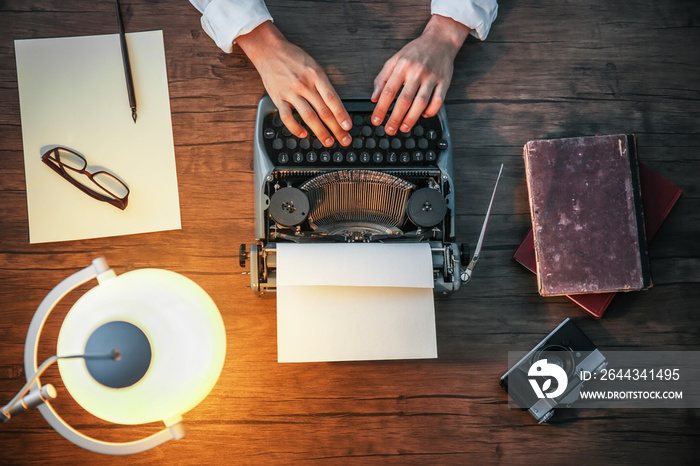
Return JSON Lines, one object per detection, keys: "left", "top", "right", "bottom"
{"left": 513, "top": 163, "right": 683, "bottom": 319}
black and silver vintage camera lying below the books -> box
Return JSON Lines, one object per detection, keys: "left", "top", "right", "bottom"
{"left": 501, "top": 318, "right": 607, "bottom": 424}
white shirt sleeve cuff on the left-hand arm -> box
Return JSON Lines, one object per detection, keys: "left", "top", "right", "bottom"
{"left": 190, "top": 0, "right": 272, "bottom": 53}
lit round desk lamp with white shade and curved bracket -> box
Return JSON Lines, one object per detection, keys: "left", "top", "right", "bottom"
{"left": 0, "top": 258, "right": 226, "bottom": 455}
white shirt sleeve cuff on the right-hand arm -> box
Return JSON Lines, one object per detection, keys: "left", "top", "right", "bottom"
{"left": 430, "top": 0, "right": 498, "bottom": 40}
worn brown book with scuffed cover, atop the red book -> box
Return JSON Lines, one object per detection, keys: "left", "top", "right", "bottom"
{"left": 524, "top": 134, "right": 652, "bottom": 296}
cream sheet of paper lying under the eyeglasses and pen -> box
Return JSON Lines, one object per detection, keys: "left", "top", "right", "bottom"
{"left": 15, "top": 31, "right": 181, "bottom": 243}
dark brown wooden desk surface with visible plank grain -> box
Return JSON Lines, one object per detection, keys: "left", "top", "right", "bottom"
{"left": 0, "top": 0, "right": 700, "bottom": 464}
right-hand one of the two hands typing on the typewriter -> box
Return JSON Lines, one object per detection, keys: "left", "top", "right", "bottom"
{"left": 371, "top": 15, "right": 470, "bottom": 135}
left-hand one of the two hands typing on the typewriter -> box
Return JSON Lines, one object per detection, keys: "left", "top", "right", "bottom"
{"left": 236, "top": 21, "right": 352, "bottom": 147}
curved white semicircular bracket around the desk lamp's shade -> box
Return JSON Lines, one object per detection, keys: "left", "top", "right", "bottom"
{"left": 24, "top": 257, "right": 185, "bottom": 455}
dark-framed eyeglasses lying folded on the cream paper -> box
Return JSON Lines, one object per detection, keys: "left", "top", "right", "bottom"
{"left": 41, "top": 147, "right": 129, "bottom": 210}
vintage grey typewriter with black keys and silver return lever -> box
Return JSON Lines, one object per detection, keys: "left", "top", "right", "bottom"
{"left": 239, "top": 96, "right": 502, "bottom": 296}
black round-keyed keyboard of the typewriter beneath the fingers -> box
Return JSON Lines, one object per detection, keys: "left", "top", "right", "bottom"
{"left": 261, "top": 100, "right": 449, "bottom": 168}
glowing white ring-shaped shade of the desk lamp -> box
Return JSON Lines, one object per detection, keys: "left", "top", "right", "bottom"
{"left": 57, "top": 269, "right": 226, "bottom": 424}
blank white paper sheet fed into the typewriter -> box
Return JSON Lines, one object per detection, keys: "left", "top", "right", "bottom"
{"left": 277, "top": 243, "right": 437, "bottom": 362}
